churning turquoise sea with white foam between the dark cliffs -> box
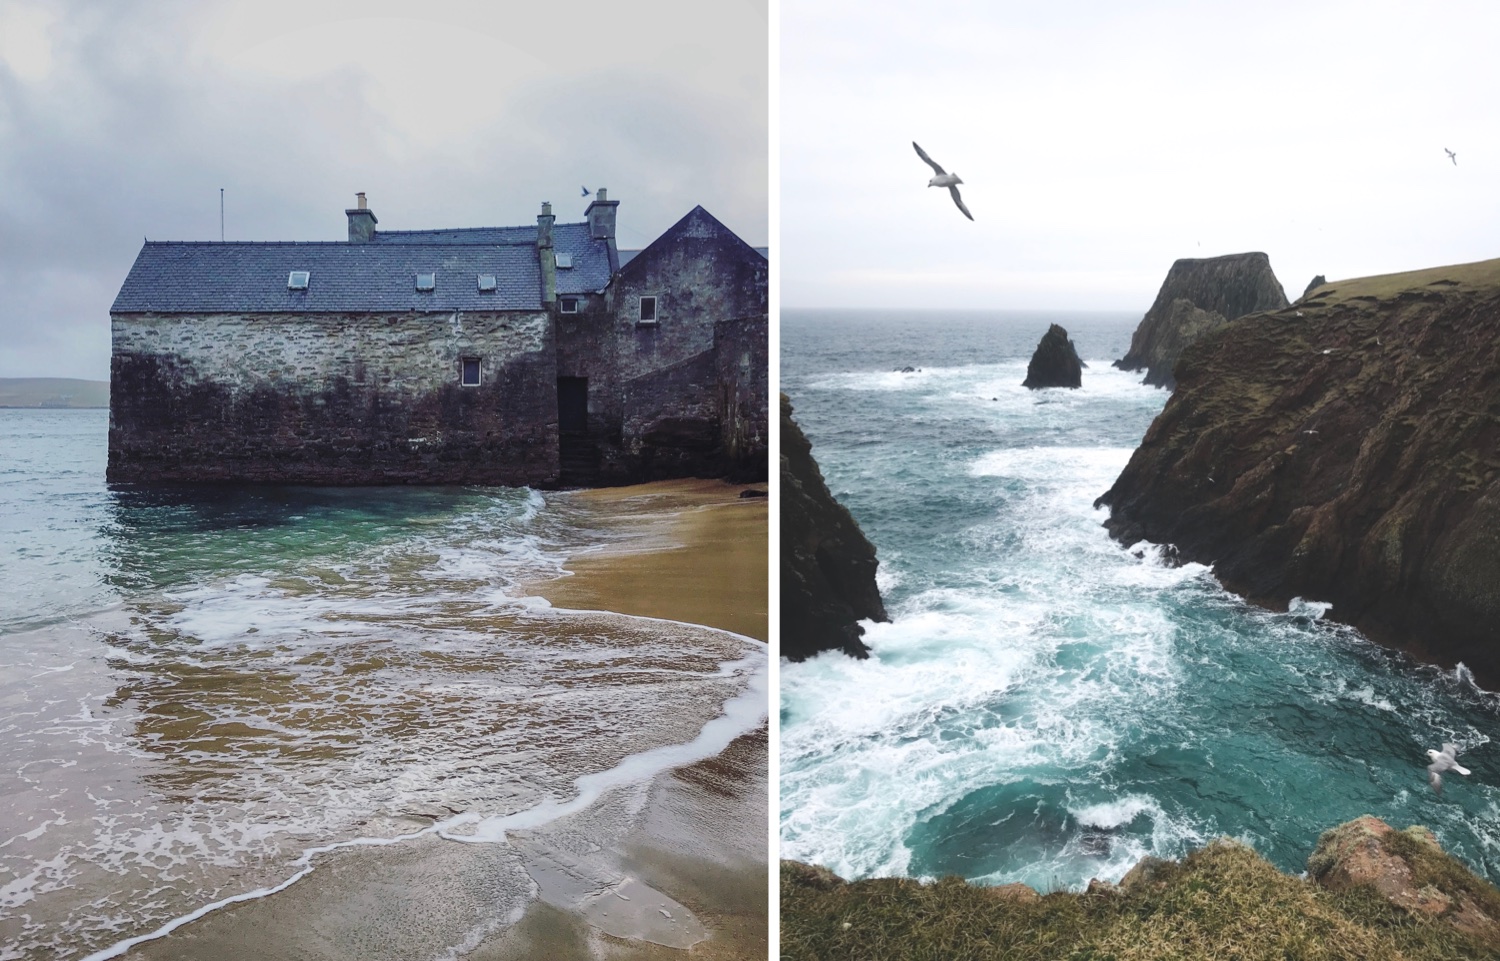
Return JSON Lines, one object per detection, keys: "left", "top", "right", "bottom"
{"left": 780, "top": 310, "right": 1500, "bottom": 889}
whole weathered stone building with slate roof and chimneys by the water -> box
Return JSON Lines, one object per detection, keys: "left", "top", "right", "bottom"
{"left": 108, "top": 189, "right": 768, "bottom": 487}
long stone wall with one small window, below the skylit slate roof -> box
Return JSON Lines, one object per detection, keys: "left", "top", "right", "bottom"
{"left": 108, "top": 312, "right": 558, "bottom": 486}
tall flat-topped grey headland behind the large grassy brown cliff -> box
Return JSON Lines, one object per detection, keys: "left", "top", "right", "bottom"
{"left": 1115, "top": 253, "right": 1287, "bottom": 390}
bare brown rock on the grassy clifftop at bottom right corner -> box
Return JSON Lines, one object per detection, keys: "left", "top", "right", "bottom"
{"left": 1308, "top": 814, "right": 1500, "bottom": 942}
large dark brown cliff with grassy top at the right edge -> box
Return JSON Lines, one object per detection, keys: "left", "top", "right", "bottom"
{"left": 1100, "top": 261, "right": 1500, "bottom": 688}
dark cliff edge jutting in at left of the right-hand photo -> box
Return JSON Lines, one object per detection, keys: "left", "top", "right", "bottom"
{"left": 782, "top": 394, "right": 888, "bottom": 661}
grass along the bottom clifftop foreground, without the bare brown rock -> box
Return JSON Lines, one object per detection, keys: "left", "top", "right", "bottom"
{"left": 782, "top": 841, "right": 1500, "bottom": 961}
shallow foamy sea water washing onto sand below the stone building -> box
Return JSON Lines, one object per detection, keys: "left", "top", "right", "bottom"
{"left": 0, "top": 409, "right": 767, "bottom": 961}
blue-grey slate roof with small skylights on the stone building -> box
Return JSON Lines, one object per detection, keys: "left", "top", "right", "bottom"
{"left": 110, "top": 223, "right": 611, "bottom": 313}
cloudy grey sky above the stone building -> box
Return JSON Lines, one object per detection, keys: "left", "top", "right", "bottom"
{"left": 0, "top": 0, "right": 770, "bottom": 379}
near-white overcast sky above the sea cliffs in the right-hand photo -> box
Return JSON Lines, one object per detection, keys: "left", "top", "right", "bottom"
{"left": 780, "top": 0, "right": 1500, "bottom": 312}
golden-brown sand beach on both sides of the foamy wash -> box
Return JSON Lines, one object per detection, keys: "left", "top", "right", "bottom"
{"left": 126, "top": 481, "right": 770, "bottom": 961}
